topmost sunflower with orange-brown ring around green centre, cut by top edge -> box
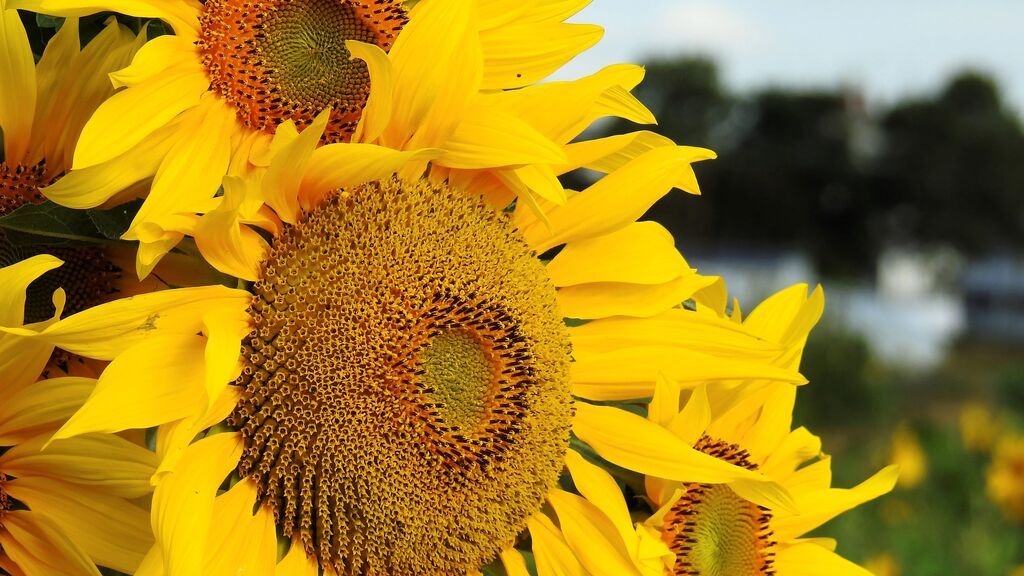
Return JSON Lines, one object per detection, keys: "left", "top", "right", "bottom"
{"left": 22, "top": 0, "right": 653, "bottom": 277}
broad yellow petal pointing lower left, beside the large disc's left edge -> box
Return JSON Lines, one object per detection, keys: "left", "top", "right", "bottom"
{"left": 53, "top": 335, "right": 205, "bottom": 440}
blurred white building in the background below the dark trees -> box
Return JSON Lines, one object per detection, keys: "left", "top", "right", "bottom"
{"left": 685, "top": 241, "right": 966, "bottom": 369}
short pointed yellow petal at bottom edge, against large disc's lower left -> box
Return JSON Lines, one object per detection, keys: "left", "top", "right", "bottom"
{"left": 203, "top": 479, "right": 278, "bottom": 576}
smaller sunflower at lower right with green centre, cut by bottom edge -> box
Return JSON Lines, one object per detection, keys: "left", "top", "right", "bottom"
{"left": 532, "top": 379, "right": 897, "bottom": 576}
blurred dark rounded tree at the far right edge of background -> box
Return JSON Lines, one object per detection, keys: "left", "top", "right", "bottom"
{"left": 867, "top": 72, "right": 1024, "bottom": 253}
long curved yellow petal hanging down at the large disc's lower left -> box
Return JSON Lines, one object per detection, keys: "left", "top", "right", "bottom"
{"left": 153, "top": 434, "right": 242, "bottom": 576}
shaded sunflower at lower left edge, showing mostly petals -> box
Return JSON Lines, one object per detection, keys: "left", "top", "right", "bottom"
{"left": 0, "top": 255, "right": 157, "bottom": 576}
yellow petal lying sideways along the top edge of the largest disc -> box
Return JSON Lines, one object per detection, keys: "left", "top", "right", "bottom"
{"left": 301, "top": 143, "right": 440, "bottom": 205}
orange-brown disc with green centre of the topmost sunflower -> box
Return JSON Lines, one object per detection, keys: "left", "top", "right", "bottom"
{"left": 198, "top": 0, "right": 408, "bottom": 142}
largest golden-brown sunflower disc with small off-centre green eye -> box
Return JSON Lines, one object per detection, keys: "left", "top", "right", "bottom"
{"left": 230, "top": 179, "right": 571, "bottom": 575}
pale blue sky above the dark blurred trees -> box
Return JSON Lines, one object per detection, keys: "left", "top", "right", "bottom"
{"left": 558, "top": 0, "right": 1024, "bottom": 111}
